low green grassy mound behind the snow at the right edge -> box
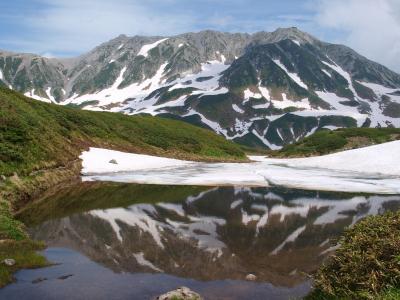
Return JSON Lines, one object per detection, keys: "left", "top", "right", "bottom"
{"left": 270, "top": 128, "right": 400, "bottom": 157}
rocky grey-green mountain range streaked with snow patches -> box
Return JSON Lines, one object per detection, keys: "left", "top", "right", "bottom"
{"left": 0, "top": 27, "right": 400, "bottom": 150}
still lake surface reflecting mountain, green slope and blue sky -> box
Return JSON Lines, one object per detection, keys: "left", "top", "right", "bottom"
{"left": 0, "top": 182, "right": 400, "bottom": 299}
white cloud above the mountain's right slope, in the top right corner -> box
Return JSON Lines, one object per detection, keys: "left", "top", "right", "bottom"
{"left": 316, "top": 0, "right": 400, "bottom": 72}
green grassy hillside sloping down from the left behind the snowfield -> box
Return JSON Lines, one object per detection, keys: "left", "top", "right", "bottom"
{"left": 0, "top": 88, "right": 245, "bottom": 176}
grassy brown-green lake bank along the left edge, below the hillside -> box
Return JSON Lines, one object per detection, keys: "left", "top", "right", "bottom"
{"left": 0, "top": 160, "right": 81, "bottom": 288}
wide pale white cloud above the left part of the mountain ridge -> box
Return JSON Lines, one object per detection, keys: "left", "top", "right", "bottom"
{"left": 19, "top": 0, "right": 193, "bottom": 53}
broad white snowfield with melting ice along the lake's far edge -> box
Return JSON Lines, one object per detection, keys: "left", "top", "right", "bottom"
{"left": 80, "top": 141, "right": 400, "bottom": 194}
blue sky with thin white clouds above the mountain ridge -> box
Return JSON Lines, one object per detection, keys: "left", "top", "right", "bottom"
{"left": 0, "top": 0, "right": 400, "bottom": 71}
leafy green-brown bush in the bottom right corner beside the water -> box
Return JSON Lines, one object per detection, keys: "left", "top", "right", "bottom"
{"left": 307, "top": 212, "right": 400, "bottom": 299}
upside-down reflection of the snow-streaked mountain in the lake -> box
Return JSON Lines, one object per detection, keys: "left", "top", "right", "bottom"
{"left": 32, "top": 187, "right": 400, "bottom": 286}
